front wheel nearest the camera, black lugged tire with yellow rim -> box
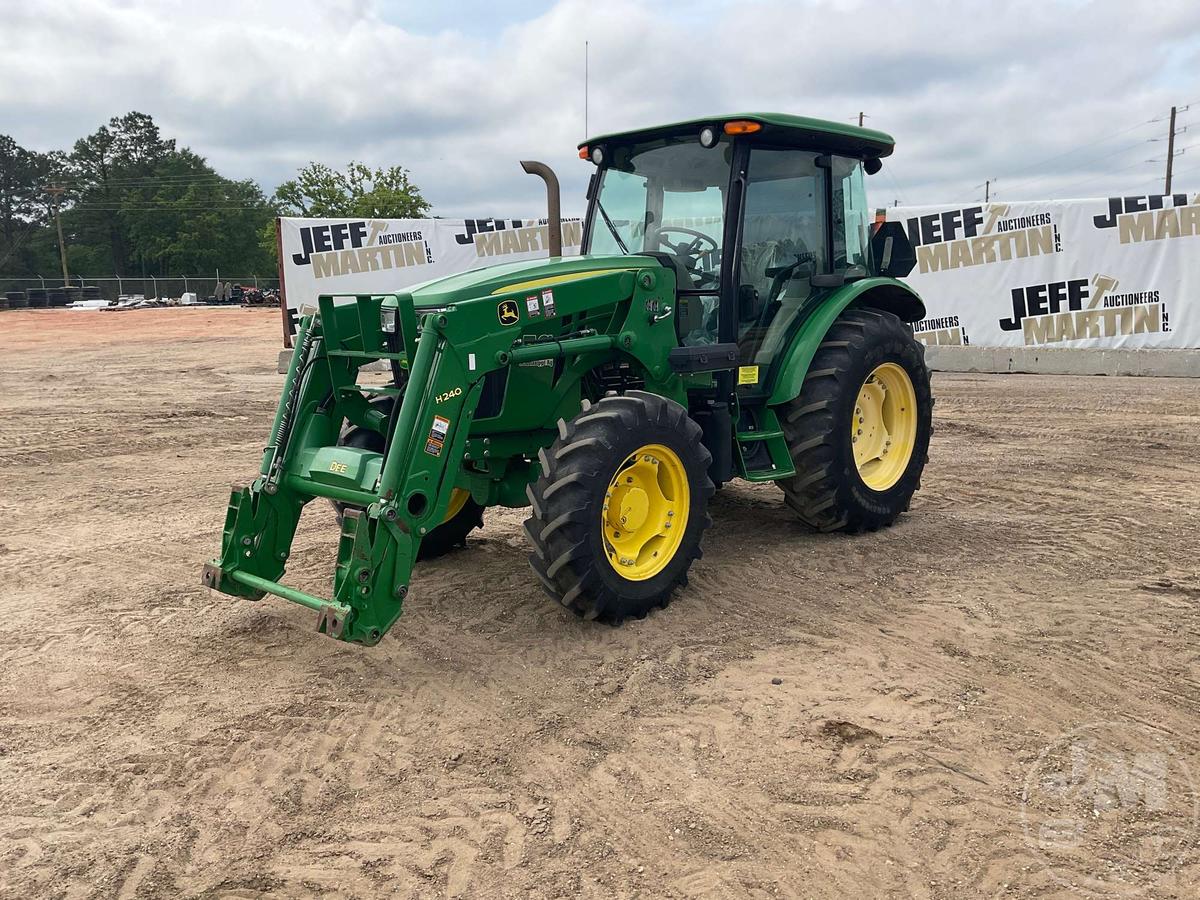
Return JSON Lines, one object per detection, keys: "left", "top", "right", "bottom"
{"left": 524, "top": 391, "right": 714, "bottom": 624}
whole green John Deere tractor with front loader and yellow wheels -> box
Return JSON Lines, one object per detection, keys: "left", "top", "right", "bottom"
{"left": 204, "top": 113, "right": 932, "bottom": 644}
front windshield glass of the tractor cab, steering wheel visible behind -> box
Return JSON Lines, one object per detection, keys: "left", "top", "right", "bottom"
{"left": 588, "top": 134, "right": 733, "bottom": 292}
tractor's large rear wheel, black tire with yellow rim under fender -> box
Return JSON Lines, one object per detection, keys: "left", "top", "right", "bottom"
{"left": 779, "top": 308, "right": 934, "bottom": 532}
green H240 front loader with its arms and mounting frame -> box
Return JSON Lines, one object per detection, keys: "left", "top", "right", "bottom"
{"left": 203, "top": 268, "right": 685, "bottom": 644}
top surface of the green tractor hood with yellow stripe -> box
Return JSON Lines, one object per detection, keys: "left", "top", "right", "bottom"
{"left": 408, "top": 256, "right": 661, "bottom": 312}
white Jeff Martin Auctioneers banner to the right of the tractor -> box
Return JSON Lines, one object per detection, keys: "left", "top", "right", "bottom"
{"left": 887, "top": 193, "right": 1200, "bottom": 348}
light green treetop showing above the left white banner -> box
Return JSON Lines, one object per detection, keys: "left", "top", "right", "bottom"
{"left": 275, "top": 162, "right": 430, "bottom": 218}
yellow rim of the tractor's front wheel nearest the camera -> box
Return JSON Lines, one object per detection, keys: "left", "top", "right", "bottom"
{"left": 600, "top": 444, "right": 690, "bottom": 581}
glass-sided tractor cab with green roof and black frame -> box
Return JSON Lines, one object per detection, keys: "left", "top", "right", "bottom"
{"left": 580, "top": 114, "right": 911, "bottom": 398}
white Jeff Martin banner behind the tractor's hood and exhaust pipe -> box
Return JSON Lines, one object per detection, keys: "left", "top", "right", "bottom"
{"left": 278, "top": 218, "right": 583, "bottom": 332}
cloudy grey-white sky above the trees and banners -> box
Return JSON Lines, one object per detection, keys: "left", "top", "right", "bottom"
{"left": 0, "top": 0, "right": 1200, "bottom": 217}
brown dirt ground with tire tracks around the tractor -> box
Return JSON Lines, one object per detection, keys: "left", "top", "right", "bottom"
{"left": 0, "top": 310, "right": 1200, "bottom": 899}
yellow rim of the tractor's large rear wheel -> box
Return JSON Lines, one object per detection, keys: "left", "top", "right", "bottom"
{"left": 850, "top": 362, "right": 917, "bottom": 491}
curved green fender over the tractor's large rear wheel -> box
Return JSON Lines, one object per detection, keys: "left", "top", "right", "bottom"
{"left": 767, "top": 278, "right": 925, "bottom": 406}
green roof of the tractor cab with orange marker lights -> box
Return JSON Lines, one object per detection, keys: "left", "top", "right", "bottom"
{"left": 580, "top": 113, "right": 895, "bottom": 160}
